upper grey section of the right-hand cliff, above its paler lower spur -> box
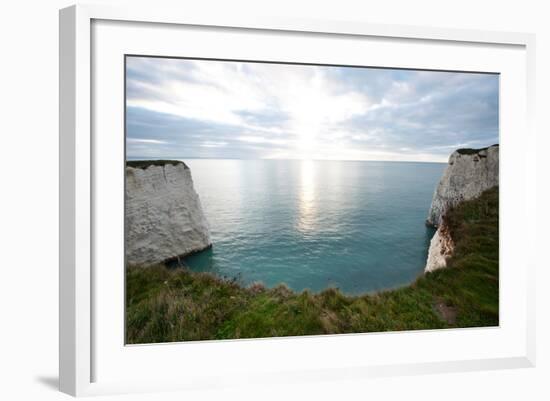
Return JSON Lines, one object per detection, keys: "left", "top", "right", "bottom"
{"left": 427, "top": 145, "right": 499, "bottom": 227}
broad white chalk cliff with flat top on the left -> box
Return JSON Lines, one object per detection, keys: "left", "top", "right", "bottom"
{"left": 125, "top": 162, "right": 212, "bottom": 264}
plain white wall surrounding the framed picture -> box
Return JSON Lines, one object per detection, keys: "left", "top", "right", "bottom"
{"left": 0, "top": 0, "right": 550, "bottom": 400}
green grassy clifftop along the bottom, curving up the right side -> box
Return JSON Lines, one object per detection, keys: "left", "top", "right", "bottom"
{"left": 126, "top": 188, "right": 499, "bottom": 343}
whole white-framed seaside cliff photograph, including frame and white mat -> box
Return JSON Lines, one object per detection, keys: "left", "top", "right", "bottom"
{"left": 60, "top": 6, "right": 536, "bottom": 395}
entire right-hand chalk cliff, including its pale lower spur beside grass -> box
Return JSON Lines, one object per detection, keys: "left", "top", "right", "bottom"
{"left": 424, "top": 145, "right": 499, "bottom": 272}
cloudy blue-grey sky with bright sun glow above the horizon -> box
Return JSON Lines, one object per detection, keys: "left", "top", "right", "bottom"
{"left": 126, "top": 56, "right": 499, "bottom": 162}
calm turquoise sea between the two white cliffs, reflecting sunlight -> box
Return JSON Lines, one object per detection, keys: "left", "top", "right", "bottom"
{"left": 180, "top": 159, "right": 445, "bottom": 294}
